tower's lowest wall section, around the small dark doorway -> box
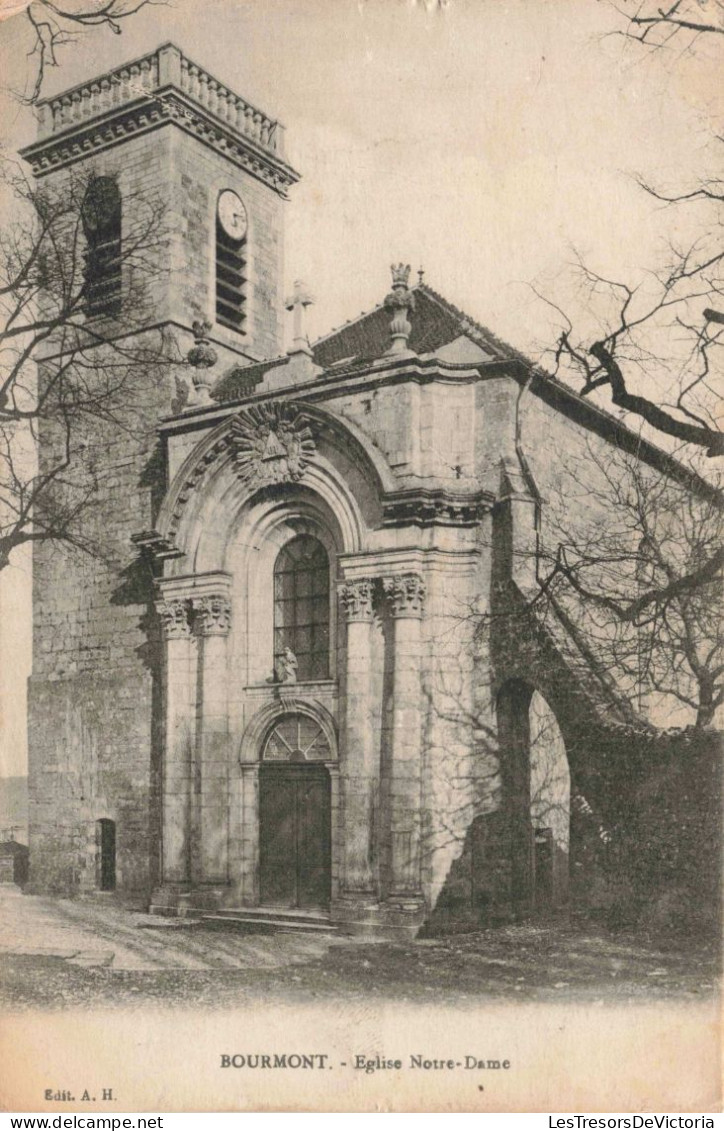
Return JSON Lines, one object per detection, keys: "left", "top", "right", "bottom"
{"left": 31, "top": 665, "right": 158, "bottom": 900}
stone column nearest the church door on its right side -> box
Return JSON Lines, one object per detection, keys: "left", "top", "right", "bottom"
{"left": 339, "top": 578, "right": 379, "bottom": 899}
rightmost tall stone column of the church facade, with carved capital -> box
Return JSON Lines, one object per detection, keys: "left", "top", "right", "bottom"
{"left": 383, "top": 573, "right": 425, "bottom": 903}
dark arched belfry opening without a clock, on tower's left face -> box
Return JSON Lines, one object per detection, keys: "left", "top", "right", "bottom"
{"left": 83, "top": 176, "right": 122, "bottom": 318}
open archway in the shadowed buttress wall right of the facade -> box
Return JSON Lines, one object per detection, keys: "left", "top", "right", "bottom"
{"left": 498, "top": 680, "right": 570, "bottom": 915}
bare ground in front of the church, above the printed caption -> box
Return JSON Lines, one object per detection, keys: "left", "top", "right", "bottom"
{"left": 0, "top": 884, "right": 718, "bottom": 1009}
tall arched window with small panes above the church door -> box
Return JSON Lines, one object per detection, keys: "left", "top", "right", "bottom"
{"left": 274, "top": 534, "right": 329, "bottom": 680}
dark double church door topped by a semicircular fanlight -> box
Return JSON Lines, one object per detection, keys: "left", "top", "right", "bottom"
{"left": 259, "top": 713, "right": 331, "bottom": 909}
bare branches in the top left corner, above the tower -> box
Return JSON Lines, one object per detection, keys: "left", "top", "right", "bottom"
{"left": 18, "top": 0, "right": 163, "bottom": 105}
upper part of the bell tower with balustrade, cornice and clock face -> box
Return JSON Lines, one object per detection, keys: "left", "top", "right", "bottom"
{"left": 21, "top": 43, "right": 298, "bottom": 361}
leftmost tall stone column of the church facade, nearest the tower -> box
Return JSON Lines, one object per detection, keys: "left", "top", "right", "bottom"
{"left": 156, "top": 598, "right": 197, "bottom": 884}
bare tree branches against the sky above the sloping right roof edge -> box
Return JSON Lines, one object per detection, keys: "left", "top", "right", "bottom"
{"left": 545, "top": 171, "right": 724, "bottom": 457}
